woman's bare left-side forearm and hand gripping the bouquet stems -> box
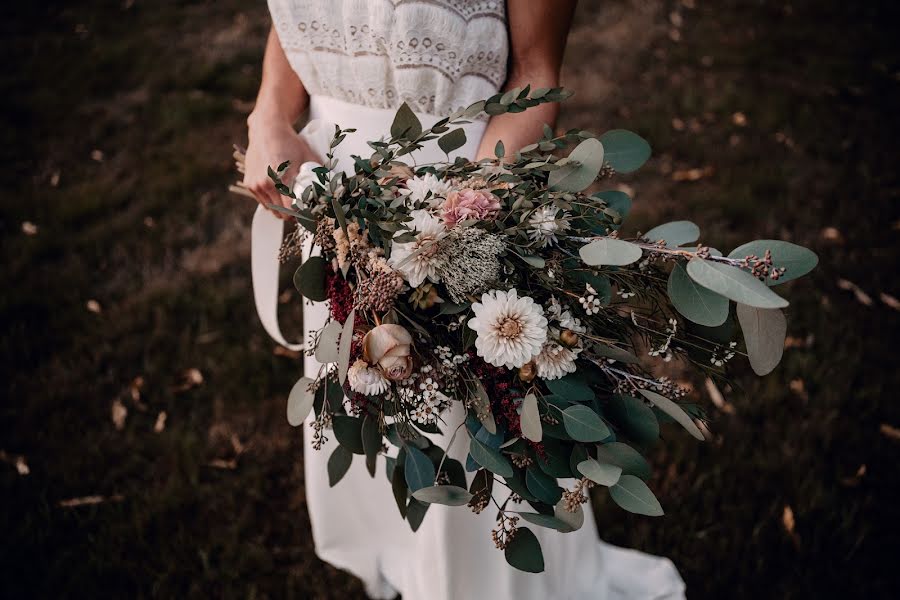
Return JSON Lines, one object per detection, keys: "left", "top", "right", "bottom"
{"left": 244, "top": 28, "right": 317, "bottom": 216}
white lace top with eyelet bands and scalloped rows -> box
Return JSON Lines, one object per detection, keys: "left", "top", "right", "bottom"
{"left": 269, "top": 0, "right": 509, "bottom": 116}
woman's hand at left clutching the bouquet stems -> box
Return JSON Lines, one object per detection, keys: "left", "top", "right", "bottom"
{"left": 244, "top": 115, "right": 321, "bottom": 218}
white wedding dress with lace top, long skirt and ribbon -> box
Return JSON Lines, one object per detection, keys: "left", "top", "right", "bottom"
{"left": 252, "top": 0, "right": 684, "bottom": 600}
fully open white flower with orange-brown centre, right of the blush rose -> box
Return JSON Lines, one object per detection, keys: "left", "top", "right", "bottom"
{"left": 469, "top": 290, "right": 547, "bottom": 369}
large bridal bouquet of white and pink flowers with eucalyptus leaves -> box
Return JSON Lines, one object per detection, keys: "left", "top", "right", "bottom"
{"left": 269, "top": 88, "right": 817, "bottom": 572}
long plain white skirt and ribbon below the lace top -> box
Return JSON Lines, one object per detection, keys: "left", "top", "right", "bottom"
{"left": 253, "top": 97, "right": 684, "bottom": 600}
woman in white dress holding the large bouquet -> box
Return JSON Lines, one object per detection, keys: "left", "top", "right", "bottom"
{"left": 244, "top": 0, "right": 684, "bottom": 600}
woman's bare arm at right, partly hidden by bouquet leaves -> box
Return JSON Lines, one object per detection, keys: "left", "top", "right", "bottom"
{"left": 478, "top": 0, "right": 577, "bottom": 158}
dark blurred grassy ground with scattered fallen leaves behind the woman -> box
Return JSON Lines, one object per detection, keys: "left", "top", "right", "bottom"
{"left": 0, "top": 0, "right": 900, "bottom": 598}
